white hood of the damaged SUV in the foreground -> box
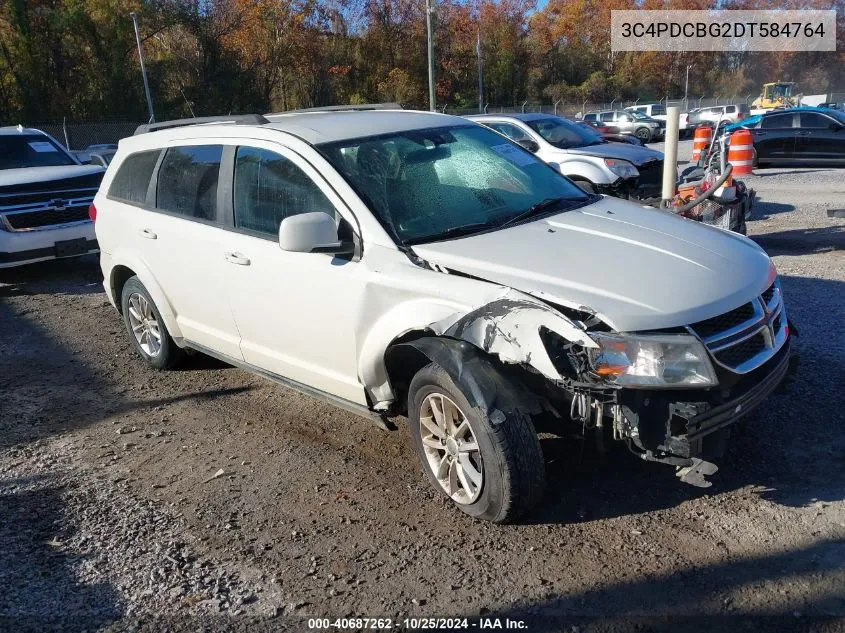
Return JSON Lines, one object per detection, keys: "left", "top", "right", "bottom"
{"left": 414, "top": 197, "right": 775, "bottom": 332}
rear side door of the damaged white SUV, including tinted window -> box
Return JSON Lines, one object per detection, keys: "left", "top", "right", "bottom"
{"left": 144, "top": 140, "right": 241, "bottom": 359}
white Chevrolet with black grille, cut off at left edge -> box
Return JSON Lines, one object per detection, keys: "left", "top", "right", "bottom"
{"left": 0, "top": 126, "right": 105, "bottom": 268}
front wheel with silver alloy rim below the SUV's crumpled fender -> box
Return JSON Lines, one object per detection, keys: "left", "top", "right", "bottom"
{"left": 408, "top": 363, "right": 545, "bottom": 523}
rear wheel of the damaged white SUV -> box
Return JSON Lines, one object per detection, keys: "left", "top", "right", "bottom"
{"left": 120, "top": 277, "right": 183, "bottom": 369}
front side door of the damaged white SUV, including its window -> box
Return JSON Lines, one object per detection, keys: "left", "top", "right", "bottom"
{"left": 218, "top": 141, "right": 366, "bottom": 404}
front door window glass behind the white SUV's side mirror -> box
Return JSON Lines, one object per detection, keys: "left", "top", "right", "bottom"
{"left": 234, "top": 147, "right": 337, "bottom": 239}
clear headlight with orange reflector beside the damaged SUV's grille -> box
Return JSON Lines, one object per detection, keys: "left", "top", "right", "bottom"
{"left": 587, "top": 333, "right": 718, "bottom": 387}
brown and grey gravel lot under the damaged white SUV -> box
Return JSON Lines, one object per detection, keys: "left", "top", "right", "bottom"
{"left": 0, "top": 142, "right": 845, "bottom": 631}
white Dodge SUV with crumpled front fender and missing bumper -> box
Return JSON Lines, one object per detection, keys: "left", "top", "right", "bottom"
{"left": 95, "top": 110, "right": 790, "bottom": 521}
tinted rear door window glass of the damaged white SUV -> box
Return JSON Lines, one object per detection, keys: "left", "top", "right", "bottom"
{"left": 156, "top": 145, "right": 223, "bottom": 220}
